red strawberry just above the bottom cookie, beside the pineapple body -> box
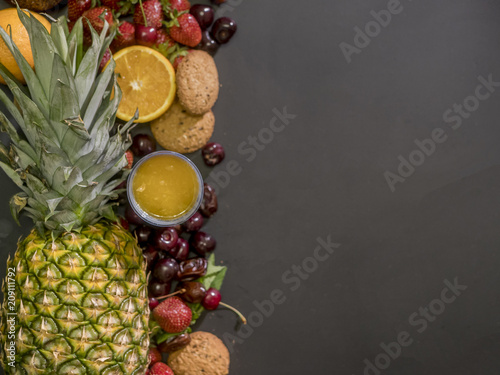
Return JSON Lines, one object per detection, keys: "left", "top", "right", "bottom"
{"left": 153, "top": 297, "right": 193, "bottom": 333}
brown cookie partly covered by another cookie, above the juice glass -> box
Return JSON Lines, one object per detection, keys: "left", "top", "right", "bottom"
{"left": 151, "top": 100, "right": 215, "bottom": 154}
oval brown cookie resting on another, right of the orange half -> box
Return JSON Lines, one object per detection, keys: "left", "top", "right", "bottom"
{"left": 175, "top": 50, "right": 219, "bottom": 115}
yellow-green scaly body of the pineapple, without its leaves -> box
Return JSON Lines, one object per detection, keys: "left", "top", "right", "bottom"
{"left": 0, "top": 220, "right": 150, "bottom": 375}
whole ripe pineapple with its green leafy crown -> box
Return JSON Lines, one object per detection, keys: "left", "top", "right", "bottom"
{"left": 0, "top": 8, "right": 150, "bottom": 375}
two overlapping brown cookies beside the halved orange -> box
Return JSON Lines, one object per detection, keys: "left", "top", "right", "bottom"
{"left": 151, "top": 50, "right": 219, "bottom": 154}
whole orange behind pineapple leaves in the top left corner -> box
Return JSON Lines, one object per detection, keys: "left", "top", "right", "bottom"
{"left": 0, "top": 8, "right": 50, "bottom": 84}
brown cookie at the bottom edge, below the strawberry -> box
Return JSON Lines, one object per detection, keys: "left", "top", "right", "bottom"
{"left": 168, "top": 331, "right": 229, "bottom": 375}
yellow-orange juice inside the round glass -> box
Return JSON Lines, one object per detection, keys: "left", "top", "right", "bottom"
{"left": 132, "top": 155, "right": 200, "bottom": 220}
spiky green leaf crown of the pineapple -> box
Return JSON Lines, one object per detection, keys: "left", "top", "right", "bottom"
{"left": 0, "top": 7, "right": 137, "bottom": 236}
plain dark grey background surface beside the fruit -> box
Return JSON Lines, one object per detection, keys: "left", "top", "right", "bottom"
{"left": 0, "top": 0, "right": 500, "bottom": 375}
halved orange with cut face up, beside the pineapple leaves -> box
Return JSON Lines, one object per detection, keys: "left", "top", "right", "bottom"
{"left": 113, "top": 46, "right": 176, "bottom": 122}
